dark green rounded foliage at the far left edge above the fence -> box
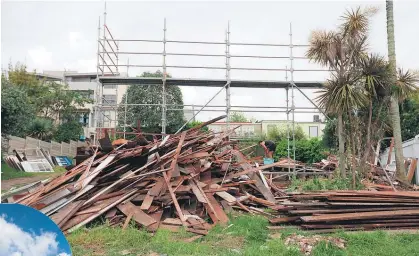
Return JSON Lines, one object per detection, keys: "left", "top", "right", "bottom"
{"left": 1, "top": 78, "right": 34, "bottom": 136}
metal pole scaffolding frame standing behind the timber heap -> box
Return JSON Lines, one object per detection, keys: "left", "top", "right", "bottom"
{"left": 94, "top": 3, "right": 329, "bottom": 172}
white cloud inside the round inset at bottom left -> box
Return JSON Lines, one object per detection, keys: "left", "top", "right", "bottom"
{"left": 0, "top": 216, "right": 69, "bottom": 256}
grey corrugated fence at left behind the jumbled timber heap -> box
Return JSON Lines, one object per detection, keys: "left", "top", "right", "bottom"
{"left": 5, "top": 136, "right": 85, "bottom": 157}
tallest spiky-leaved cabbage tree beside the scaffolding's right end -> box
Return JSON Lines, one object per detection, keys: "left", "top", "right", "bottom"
{"left": 307, "top": 8, "right": 374, "bottom": 177}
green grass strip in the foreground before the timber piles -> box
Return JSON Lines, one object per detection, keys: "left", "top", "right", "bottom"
{"left": 67, "top": 215, "right": 419, "bottom": 256}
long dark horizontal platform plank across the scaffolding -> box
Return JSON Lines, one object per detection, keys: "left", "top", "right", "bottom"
{"left": 99, "top": 76, "right": 323, "bottom": 89}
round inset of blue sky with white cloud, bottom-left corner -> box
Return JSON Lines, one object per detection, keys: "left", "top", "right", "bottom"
{"left": 0, "top": 204, "right": 71, "bottom": 256}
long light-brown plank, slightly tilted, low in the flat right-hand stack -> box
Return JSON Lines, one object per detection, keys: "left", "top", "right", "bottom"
{"left": 301, "top": 210, "right": 419, "bottom": 222}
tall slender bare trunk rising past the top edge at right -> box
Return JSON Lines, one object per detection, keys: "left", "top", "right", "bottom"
{"left": 386, "top": 0, "right": 406, "bottom": 181}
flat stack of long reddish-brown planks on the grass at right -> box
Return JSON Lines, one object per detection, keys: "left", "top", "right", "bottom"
{"left": 270, "top": 191, "right": 419, "bottom": 232}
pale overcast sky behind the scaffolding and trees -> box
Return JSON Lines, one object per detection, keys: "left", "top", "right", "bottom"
{"left": 1, "top": 0, "right": 419, "bottom": 121}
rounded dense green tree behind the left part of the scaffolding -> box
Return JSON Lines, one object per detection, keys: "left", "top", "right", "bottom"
{"left": 118, "top": 71, "right": 184, "bottom": 133}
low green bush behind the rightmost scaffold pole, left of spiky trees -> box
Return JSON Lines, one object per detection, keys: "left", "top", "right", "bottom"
{"left": 274, "top": 138, "right": 326, "bottom": 163}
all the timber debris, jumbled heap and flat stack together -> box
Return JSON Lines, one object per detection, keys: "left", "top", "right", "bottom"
{"left": 2, "top": 116, "right": 419, "bottom": 235}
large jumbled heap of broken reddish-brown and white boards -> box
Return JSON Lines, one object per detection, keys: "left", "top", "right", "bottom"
{"left": 8, "top": 117, "right": 280, "bottom": 235}
